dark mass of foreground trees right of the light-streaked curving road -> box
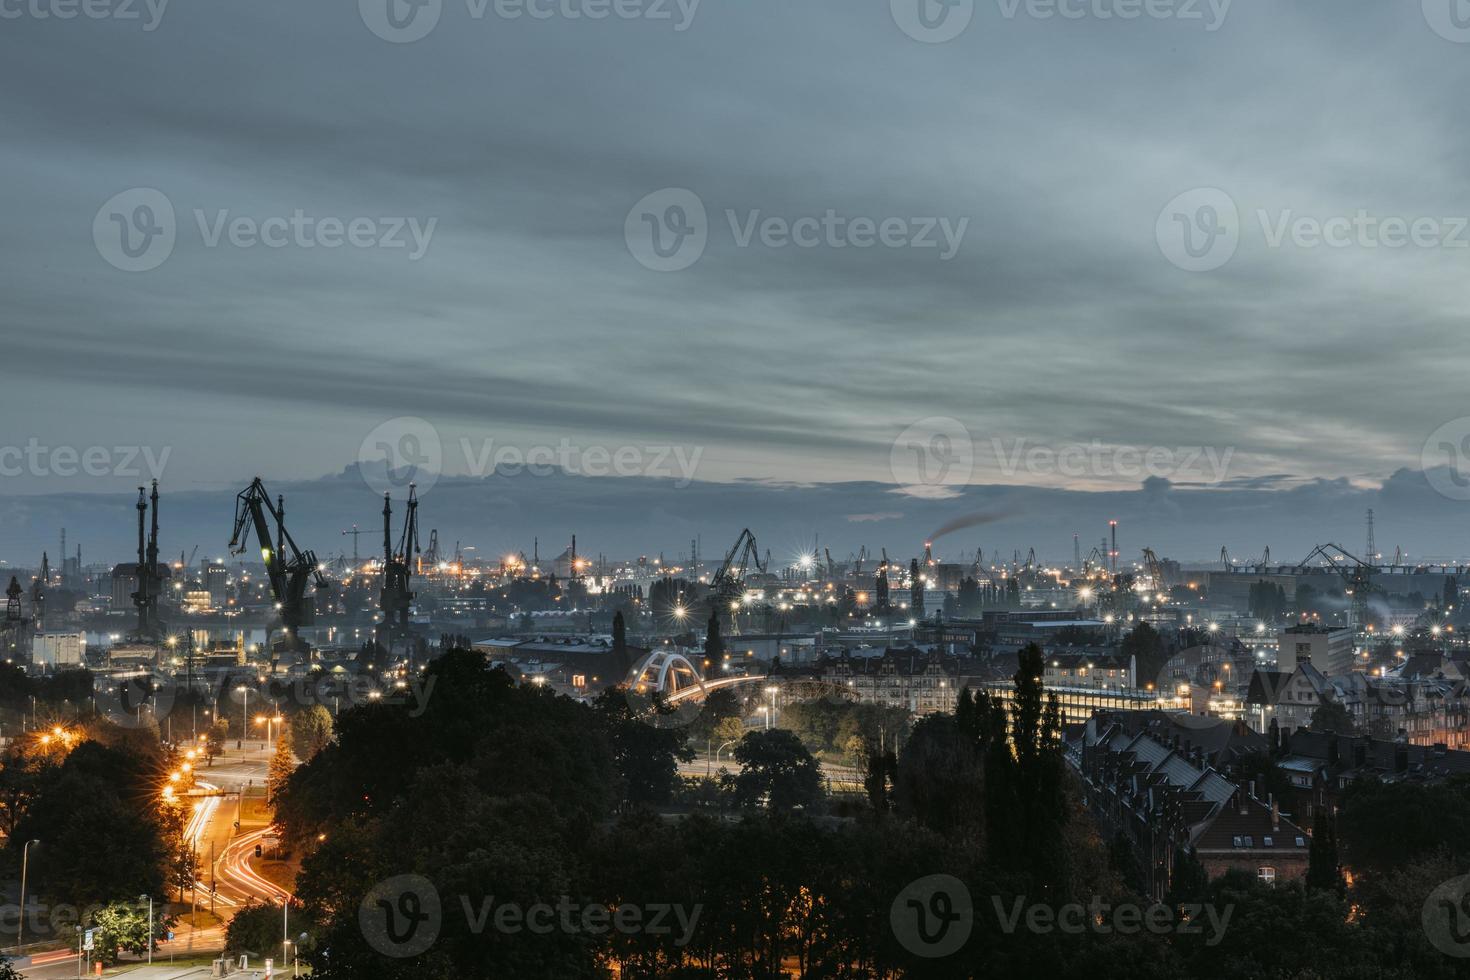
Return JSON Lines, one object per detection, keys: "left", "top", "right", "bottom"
{"left": 276, "top": 649, "right": 1470, "bottom": 980}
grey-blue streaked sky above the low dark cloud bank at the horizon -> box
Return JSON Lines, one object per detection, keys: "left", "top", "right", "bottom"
{"left": 0, "top": 0, "right": 1470, "bottom": 551}
